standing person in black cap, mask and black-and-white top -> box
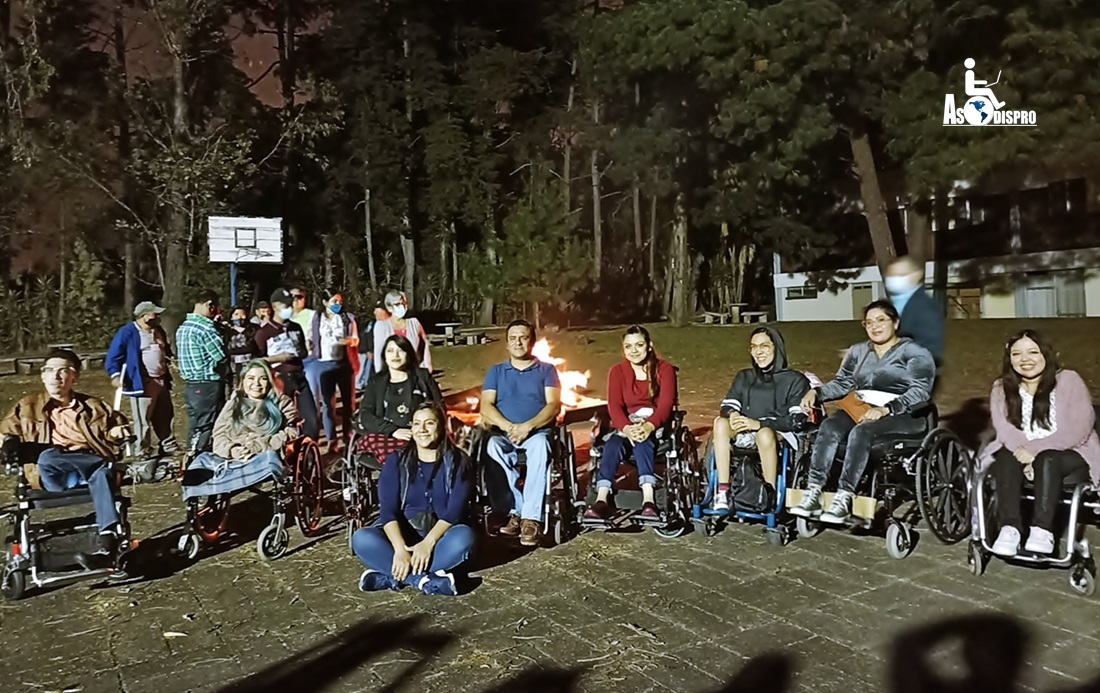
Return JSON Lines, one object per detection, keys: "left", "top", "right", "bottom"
{"left": 256, "top": 289, "right": 320, "bottom": 440}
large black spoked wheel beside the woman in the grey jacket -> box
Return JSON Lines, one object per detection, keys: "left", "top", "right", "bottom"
{"left": 916, "top": 430, "right": 970, "bottom": 543}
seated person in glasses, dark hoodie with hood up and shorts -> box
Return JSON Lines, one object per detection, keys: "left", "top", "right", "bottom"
{"left": 711, "top": 327, "right": 810, "bottom": 510}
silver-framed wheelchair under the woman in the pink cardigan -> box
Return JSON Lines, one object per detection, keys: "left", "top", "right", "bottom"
{"left": 967, "top": 405, "right": 1100, "bottom": 596}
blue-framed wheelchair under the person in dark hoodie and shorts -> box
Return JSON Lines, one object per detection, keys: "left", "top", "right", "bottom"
{"left": 692, "top": 433, "right": 809, "bottom": 547}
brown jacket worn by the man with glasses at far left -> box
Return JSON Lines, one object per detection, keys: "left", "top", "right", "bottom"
{"left": 0, "top": 392, "right": 130, "bottom": 485}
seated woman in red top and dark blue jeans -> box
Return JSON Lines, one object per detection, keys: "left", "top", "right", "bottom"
{"left": 584, "top": 325, "right": 677, "bottom": 520}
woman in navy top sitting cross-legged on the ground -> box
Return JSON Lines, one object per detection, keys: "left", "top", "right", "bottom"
{"left": 352, "top": 403, "right": 474, "bottom": 595}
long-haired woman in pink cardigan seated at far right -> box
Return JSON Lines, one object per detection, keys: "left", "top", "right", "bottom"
{"left": 979, "top": 330, "right": 1100, "bottom": 557}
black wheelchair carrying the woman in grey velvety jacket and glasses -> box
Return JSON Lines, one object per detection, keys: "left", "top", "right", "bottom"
{"left": 787, "top": 403, "right": 972, "bottom": 560}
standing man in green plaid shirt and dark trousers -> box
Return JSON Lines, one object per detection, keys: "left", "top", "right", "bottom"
{"left": 176, "top": 292, "right": 228, "bottom": 452}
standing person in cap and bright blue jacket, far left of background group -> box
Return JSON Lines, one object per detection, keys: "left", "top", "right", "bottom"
{"left": 103, "top": 300, "right": 176, "bottom": 460}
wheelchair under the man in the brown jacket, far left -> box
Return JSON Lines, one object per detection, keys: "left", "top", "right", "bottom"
{"left": 0, "top": 443, "right": 136, "bottom": 601}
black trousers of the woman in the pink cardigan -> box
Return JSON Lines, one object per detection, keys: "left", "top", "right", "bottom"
{"left": 989, "top": 448, "right": 1089, "bottom": 534}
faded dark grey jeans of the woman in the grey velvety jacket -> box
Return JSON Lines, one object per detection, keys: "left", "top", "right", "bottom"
{"left": 810, "top": 411, "right": 926, "bottom": 493}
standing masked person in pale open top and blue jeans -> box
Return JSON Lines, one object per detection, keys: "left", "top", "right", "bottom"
{"left": 306, "top": 288, "right": 359, "bottom": 452}
